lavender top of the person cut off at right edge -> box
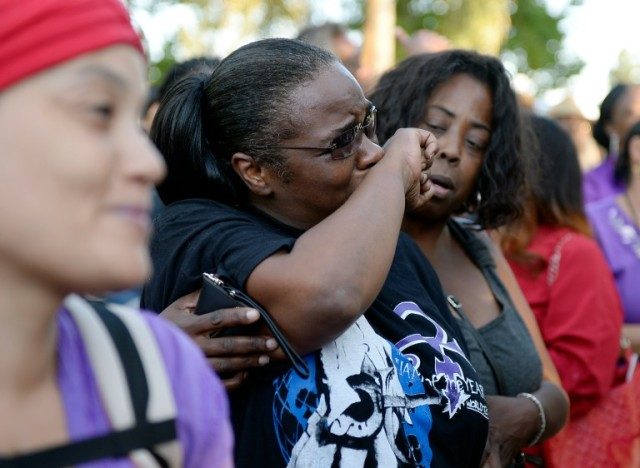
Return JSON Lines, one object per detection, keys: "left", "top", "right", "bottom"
{"left": 587, "top": 196, "right": 640, "bottom": 323}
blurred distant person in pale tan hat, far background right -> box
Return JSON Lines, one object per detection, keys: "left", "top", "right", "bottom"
{"left": 549, "top": 94, "right": 603, "bottom": 172}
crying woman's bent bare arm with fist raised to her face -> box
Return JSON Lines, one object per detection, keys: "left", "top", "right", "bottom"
{"left": 246, "top": 129, "right": 437, "bottom": 352}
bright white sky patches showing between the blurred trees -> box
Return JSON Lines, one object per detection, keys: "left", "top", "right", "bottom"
{"left": 134, "top": 0, "right": 640, "bottom": 118}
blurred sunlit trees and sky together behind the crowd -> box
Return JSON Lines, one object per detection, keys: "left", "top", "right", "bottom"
{"left": 127, "top": 0, "right": 640, "bottom": 119}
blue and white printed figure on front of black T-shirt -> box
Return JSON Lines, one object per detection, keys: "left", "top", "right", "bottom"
{"left": 273, "top": 317, "right": 438, "bottom": 468}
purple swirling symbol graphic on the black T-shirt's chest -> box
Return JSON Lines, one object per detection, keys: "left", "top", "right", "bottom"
{"left": 393, "top": 302, "right": 470, "bottom": 418}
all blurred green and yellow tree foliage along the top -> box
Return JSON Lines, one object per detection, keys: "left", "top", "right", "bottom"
{"left": 135, "top": 0, "right": 583, "bottom": 89}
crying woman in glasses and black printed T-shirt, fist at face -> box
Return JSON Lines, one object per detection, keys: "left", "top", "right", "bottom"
{"left": 143, "top": 39, "right": 488, "bottom": 467}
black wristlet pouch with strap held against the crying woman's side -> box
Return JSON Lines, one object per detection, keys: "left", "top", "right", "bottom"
{"left": 195, "top": 273, "right": 309, "bottom": 377}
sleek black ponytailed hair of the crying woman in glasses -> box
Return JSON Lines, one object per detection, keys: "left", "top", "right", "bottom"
{"left": 151, "top": 39, "right": 337, "bottom": 205}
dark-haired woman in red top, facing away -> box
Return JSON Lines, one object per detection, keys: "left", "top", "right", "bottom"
{"left": 500, "top": 116, "right": 622, "bottom": 442}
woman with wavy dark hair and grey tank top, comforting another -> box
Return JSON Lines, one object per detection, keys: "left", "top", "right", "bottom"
{"left": 369, "top": 51, "right": 568, "bottom": 466}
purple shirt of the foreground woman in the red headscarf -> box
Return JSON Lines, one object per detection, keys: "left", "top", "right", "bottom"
{"left": 57, "top": 309, "right": 233, "bottom": 468}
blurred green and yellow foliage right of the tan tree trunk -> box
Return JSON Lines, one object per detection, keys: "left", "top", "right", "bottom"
{"left": 353, "top": 0, "right": 584, "bottom": 89}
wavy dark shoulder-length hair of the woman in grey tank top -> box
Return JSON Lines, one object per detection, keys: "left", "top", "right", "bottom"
{"left": 369, "top": 50, "right": 526, "bottom": 228}
